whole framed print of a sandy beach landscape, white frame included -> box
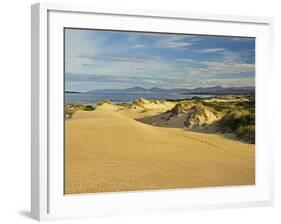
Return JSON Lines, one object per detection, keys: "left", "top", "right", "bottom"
{"left": 31, "top": 3, "right": 273, "bottom": 220}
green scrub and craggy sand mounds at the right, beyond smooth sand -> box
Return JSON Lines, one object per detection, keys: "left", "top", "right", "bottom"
{"left": 162, "top": 97, "right": 255, "bottom": 143}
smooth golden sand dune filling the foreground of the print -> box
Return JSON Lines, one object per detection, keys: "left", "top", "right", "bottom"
{"left": 65, "top": 104, "right": 255, "bottom": 194}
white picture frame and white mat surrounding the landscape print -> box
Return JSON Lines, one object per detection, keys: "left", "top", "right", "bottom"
{"left": 31, "top": 3, "right": 274, "bottom": 220}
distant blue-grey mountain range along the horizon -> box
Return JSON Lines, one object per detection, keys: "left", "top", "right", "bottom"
{"left": 83, "top": 86, "right": 255, "bottom": 95}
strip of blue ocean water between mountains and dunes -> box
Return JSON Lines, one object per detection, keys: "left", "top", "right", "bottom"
{"left": 64, "top": 93, "right": 210, "bottom": 104}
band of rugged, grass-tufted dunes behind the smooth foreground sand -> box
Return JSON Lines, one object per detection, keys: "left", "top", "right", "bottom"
{"left": 65, "top": 94, "right": 255, "bottom": 144}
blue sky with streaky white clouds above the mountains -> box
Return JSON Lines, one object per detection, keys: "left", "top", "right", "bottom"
{"left": 64, "top": 28, "right": 255, "bottom": 91}
